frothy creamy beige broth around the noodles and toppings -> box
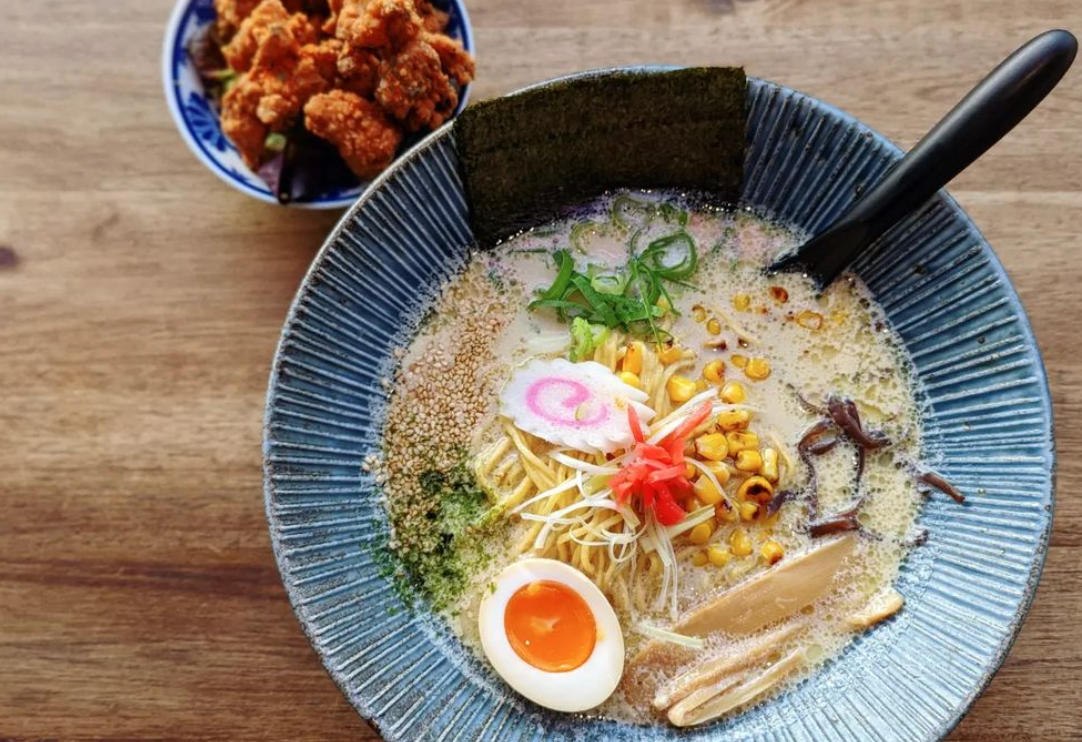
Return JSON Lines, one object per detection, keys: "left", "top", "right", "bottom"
{"left": 380, "top": 196, "right": 921, "bottom": 723}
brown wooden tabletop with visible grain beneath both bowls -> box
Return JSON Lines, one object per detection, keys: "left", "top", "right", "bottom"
{"left": 0, "top": 0, "right": 1082, "bottom": 742}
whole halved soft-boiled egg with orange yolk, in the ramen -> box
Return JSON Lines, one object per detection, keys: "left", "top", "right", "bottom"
{"left": 479, "top": 559, "right": 623, "bottom": 712}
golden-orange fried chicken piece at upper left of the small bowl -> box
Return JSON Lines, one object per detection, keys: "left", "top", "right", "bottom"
{"left": 222, "top": 0, "right": 317, "bottom": 72}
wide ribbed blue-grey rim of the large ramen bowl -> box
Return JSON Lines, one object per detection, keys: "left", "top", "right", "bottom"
{"left": 264, "top": 68, "right": 1054, "bottom": 742}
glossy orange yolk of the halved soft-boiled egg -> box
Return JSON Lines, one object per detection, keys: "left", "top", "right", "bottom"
{"left": 503, "top": 580, "right": 597, "bottom": 673}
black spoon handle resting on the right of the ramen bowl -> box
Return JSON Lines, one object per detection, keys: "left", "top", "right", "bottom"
{"left": 770, "top": 29, "right": 1078, "bottom": 288}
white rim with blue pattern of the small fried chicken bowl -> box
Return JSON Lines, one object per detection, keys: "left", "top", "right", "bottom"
{"left": 161, "top": 0, "right": 474, "bottom": 209}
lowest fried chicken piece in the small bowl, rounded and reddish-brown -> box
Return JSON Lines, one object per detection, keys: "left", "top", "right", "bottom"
{"left": 304, "top": 90, "right": 403, "bottom": 178}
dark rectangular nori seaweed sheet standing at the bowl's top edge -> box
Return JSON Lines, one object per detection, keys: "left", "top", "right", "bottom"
{"left": 454, "top": 67, "right": 747, "bottom": 247}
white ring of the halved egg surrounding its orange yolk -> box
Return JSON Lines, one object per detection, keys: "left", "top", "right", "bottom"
{"left": 478, "top": 559, "right": 623, "bottom": 712}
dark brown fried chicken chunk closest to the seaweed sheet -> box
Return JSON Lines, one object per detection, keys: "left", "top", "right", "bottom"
{"left": 375, "top": 40, "right": 459, "bottom": 131}
